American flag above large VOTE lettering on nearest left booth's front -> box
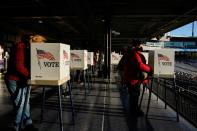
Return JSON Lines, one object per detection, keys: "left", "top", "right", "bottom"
{"left": 37, "top": 49, "right": 55, "bottom": 61}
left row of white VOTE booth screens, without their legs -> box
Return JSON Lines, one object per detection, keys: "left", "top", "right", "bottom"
{"left": 31, "top": 43, "right": 94, "bottom": 80}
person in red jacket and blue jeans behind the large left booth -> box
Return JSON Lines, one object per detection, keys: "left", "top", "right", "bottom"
{"left": 5, "top": 35, "right": 38, "bottom": 131}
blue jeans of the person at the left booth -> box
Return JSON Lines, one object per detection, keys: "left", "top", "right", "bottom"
{"left": 5, "top": 80, "right": 32, "bottom": 130}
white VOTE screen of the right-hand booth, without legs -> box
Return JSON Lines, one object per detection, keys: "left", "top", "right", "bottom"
{"left": 148, "top": 49, "right": 175, "bottom": 78}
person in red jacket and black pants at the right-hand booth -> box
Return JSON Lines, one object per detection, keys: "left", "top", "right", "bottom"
{"left": 123, "top": 40, "right": 152, "bottom": 116}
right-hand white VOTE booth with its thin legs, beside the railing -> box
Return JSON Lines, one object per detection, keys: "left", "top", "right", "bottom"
{"left": 145, "top": 48, "right": 179, "bottom": 121}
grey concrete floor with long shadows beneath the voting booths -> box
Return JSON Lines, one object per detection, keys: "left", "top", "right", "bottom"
{"left": 0, "top": 75, "right": 197, "bottom": 131}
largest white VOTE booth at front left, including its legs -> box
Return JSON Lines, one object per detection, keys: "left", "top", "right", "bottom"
{"left": 28, "top": 43, "right": 74, "bottom": 131}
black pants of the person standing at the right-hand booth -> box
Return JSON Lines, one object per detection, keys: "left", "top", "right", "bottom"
{"left": 127, "top": 83, "right": 140, "bottom": 114}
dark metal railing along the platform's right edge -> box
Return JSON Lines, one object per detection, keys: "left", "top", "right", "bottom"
{"left": 153, "top": 76, "right": 197, "bottom": 127}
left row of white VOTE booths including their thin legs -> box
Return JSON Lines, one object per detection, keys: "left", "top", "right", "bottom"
{"left": 21, "top": 43, "right": 94, "bottom": 131}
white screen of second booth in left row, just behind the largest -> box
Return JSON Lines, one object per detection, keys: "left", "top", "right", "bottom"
{"left": 70, "top": 50, "right": 88, "bottom": 70}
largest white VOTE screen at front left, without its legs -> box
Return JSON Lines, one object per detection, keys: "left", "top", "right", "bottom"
{"left": 31, "top": 43, "right": 70, "bottom": 80}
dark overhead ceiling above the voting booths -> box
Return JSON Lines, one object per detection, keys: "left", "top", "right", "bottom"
{"left": 0, "top": 0, "right": 197, "bottom": 50}
